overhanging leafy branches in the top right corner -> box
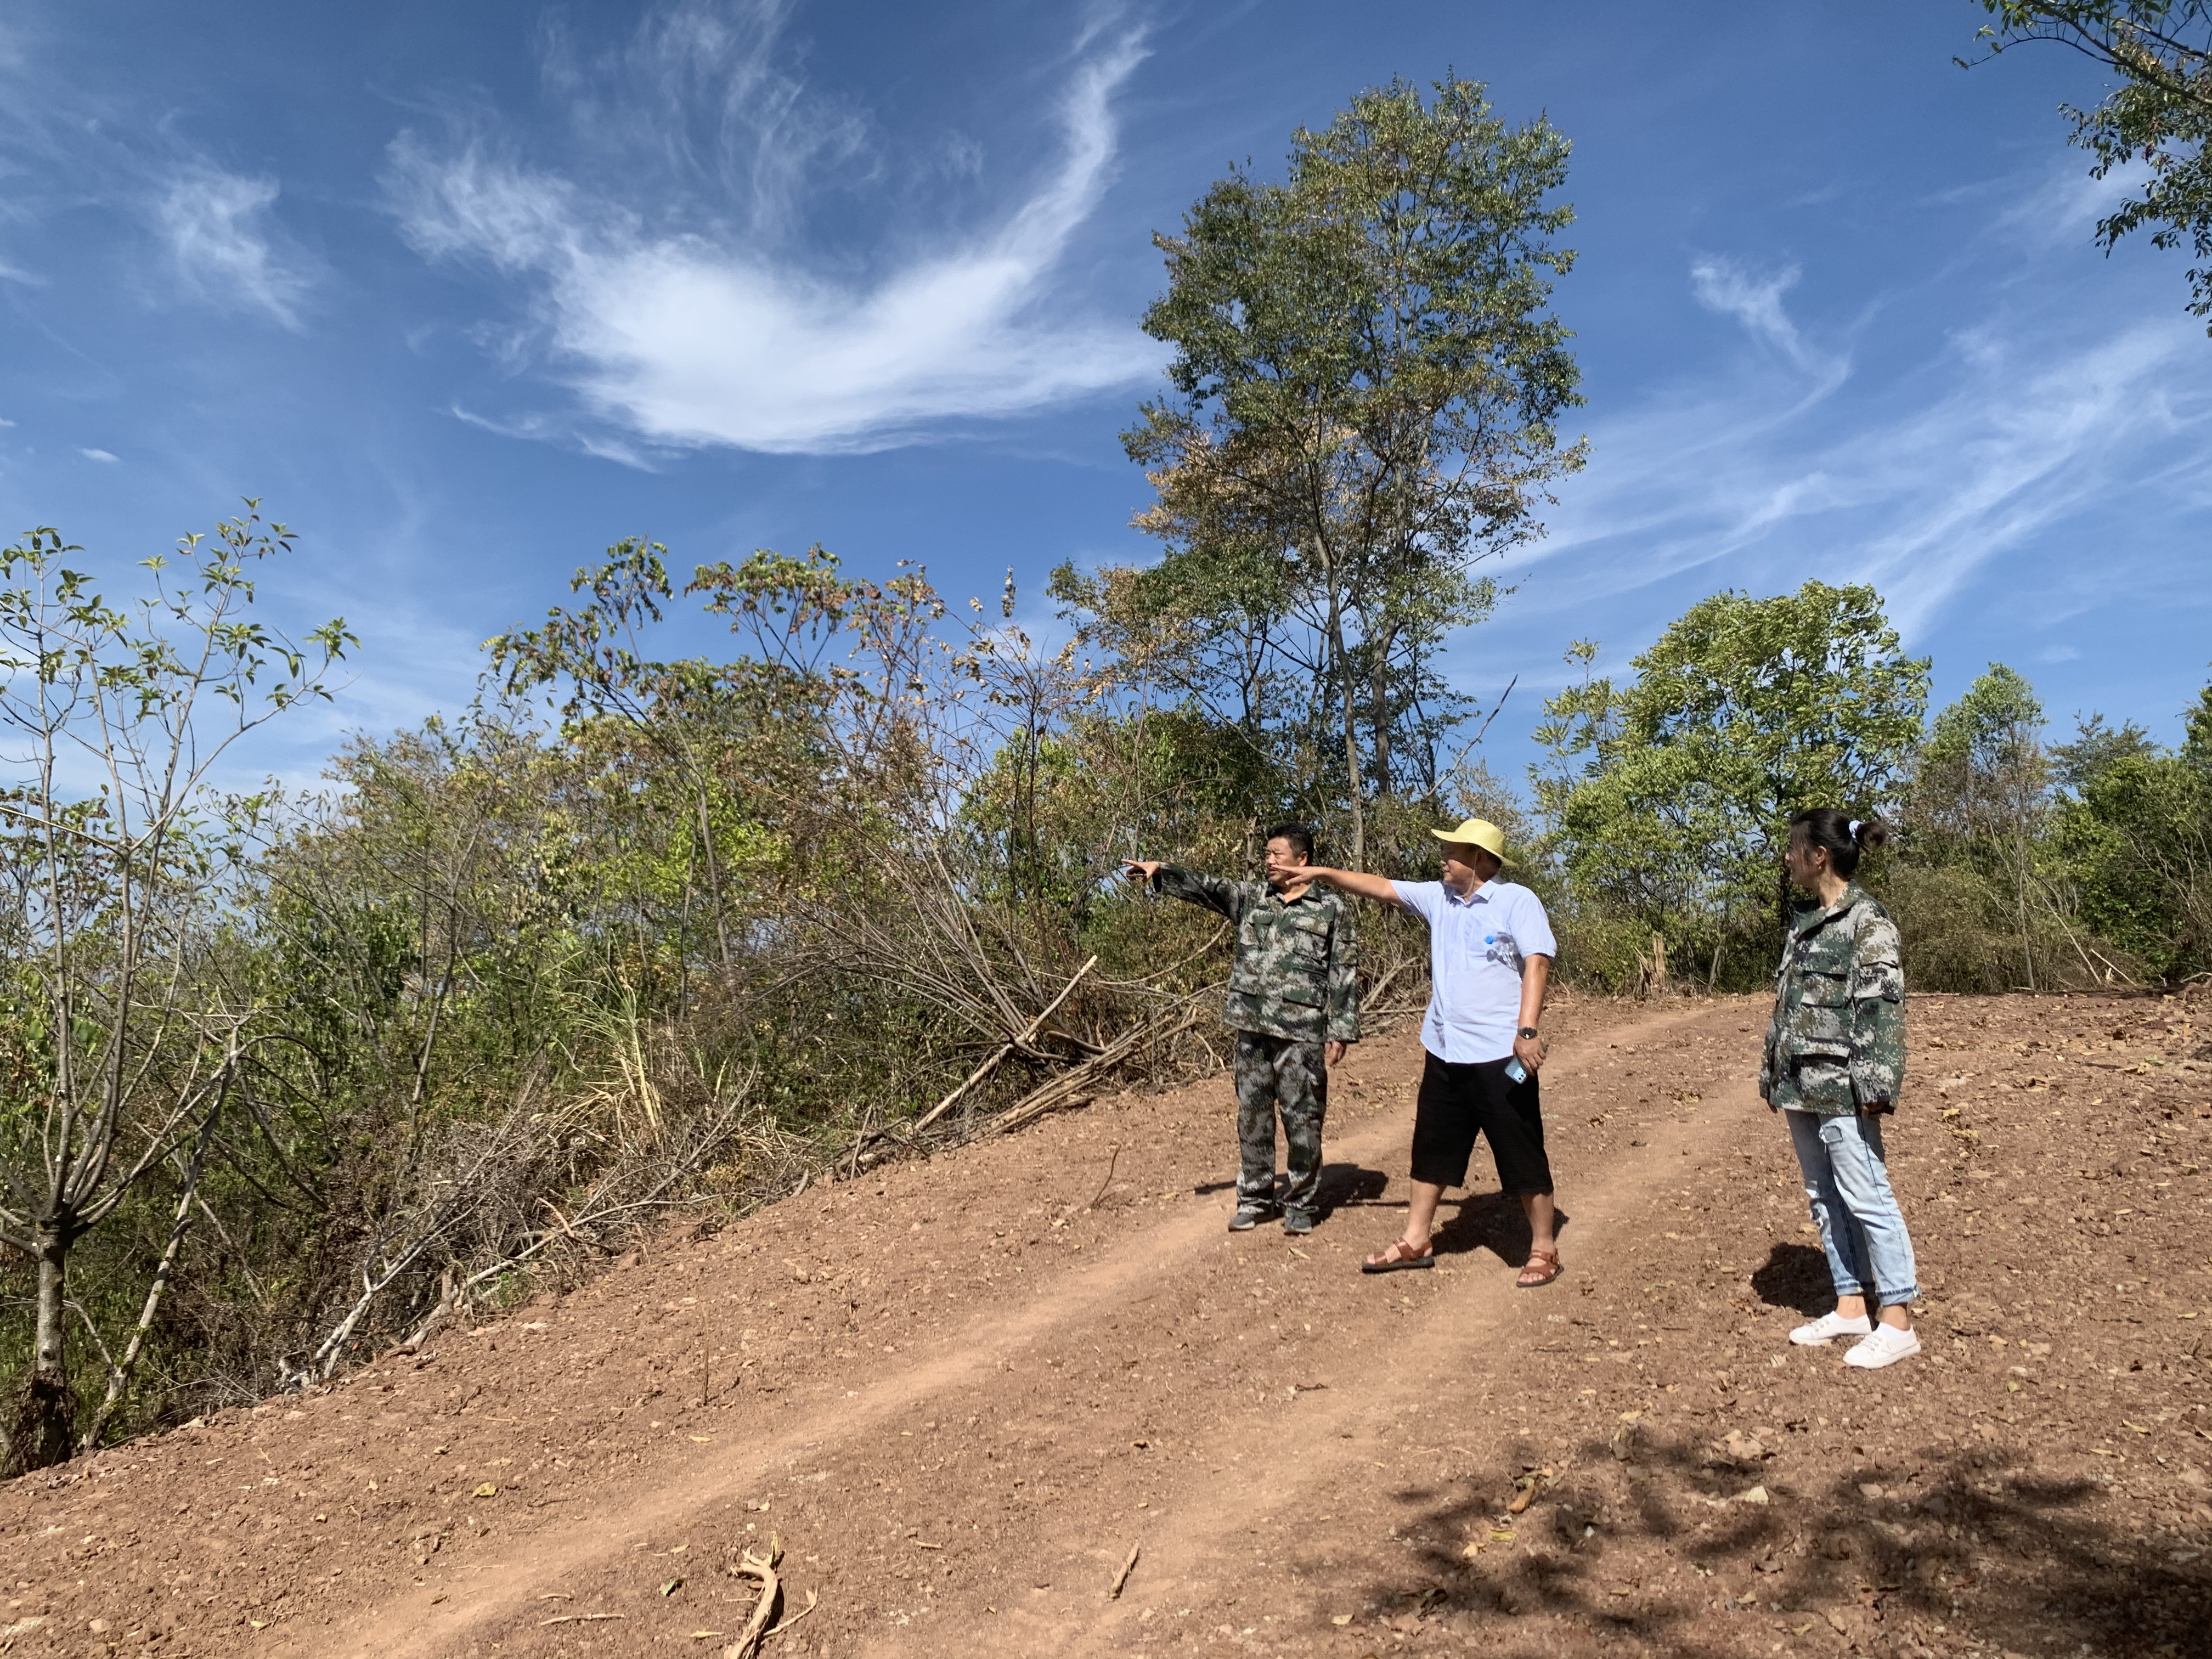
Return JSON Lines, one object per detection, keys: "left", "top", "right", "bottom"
{"left": 1962, "top": 0, "right": 2212, "bottom": 332}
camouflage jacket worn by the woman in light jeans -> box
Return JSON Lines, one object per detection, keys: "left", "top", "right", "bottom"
{"left": 1758, "top": 885, "right": 1905, "bottom": 1117}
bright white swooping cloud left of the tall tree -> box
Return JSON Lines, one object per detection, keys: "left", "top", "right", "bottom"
{"left": 392, "top": 7, "right": 1159, "bottom": 454}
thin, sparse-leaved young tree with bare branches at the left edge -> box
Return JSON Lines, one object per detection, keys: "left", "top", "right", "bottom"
{"left": 0, "top": 517, "right": 354, "bottom": 1466}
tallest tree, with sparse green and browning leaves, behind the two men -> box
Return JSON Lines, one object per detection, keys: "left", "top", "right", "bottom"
{"left": 1124, "top": 75, "right": 1584, "bottom": 862}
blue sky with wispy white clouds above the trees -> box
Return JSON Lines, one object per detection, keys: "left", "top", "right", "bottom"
{"left": 0, "top": 0, "right": 2212, "bottom": 796}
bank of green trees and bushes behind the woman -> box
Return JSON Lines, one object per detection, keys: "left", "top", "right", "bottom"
{"left": 1535, "top": 582, "right": 2212, "bottom": 991}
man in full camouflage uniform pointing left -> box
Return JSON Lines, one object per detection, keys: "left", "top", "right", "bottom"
{"left": 1124, "top": 823, "right": 1361, "bottom": 1232}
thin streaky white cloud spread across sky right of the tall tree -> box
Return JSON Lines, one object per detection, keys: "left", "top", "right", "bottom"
{"left": 1471, "top": 172, "right": 2212, "bottom": 716}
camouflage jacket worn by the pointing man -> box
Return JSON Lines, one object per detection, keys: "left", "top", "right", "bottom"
{"left": 1153, "top": 865, "right": 1361, "bottom": 1042}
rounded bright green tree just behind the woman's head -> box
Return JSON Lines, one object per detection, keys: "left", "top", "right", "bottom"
{"left": 1535, "top": 582, "right": 1929, "bottom": 969}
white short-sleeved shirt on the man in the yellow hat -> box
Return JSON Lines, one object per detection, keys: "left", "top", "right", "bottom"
{"left": 1391, "top": 881, "right": 1560, "bottom": 1066}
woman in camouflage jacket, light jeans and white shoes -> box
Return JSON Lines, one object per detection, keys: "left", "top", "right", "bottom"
{"left": 1758, "top": 808, "right": 1920, "bottom": 1369}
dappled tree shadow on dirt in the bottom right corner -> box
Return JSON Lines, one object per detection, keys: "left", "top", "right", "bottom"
{"left": 1283, "top": 1425, "right": 2212, "bottom": 1659}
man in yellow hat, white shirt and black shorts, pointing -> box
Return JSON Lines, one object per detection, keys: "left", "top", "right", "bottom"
{"left": 1310, "top": 819, "right": 1560, "bottom": 1290}
